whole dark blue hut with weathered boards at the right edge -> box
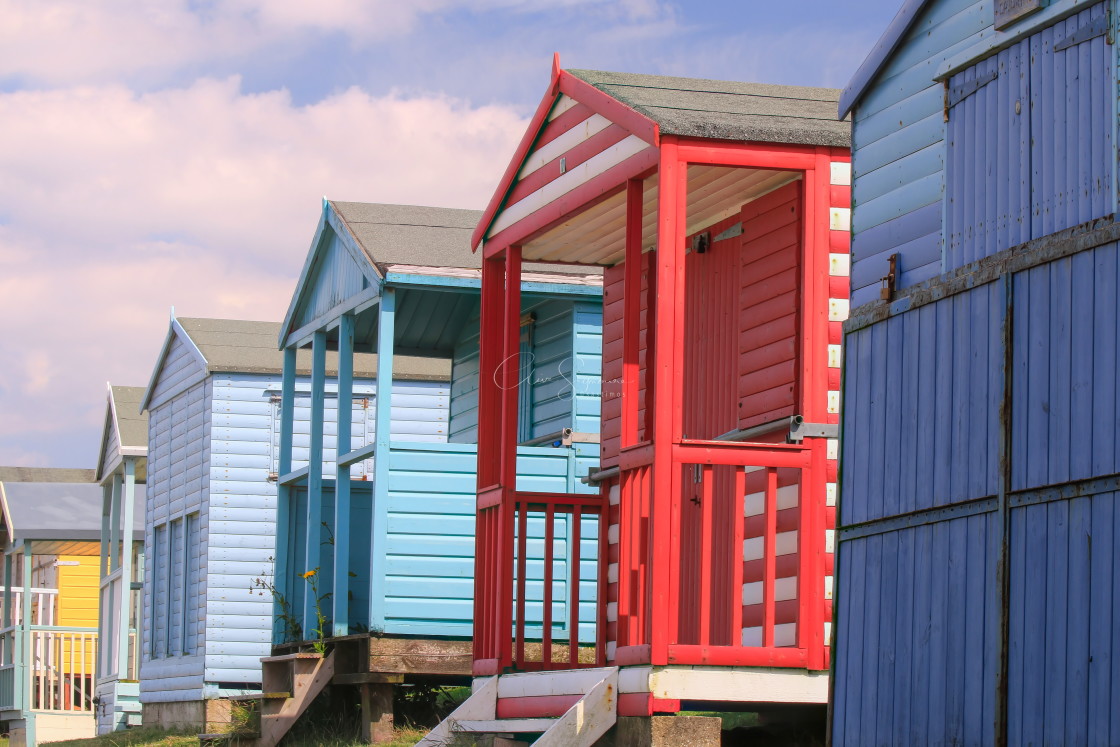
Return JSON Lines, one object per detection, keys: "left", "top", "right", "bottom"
{"left": 831, "top": 0, "right": 1120, "bottom": 745}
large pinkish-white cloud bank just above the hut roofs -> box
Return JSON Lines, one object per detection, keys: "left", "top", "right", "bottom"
{"left": 0, "top": 77, "right": 526, "bottom": 465}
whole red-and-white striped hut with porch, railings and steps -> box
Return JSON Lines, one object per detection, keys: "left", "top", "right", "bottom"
{"left": 421, "top": 59, "right": 849, "bottom": 745}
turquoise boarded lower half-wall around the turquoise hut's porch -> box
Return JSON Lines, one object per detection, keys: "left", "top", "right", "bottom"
{"left": 288, "top": 441, "right": 598, "bottom": 642}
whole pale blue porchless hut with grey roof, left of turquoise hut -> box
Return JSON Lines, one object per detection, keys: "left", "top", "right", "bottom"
{"left": 140, "top": 318, "right": 449, "bottom": 731}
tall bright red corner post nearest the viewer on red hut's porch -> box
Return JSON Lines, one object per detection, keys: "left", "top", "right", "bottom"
{"left": 646, "top": 138, "right": 688, "bottom": 665}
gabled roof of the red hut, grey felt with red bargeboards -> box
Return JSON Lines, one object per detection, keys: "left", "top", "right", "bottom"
{"left": 470, "top": 55, "right": 851, "bottom": 249}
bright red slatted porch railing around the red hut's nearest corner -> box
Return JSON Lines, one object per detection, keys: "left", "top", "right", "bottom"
{"left": 613, "top": 440, "right": 827, "bottom": 669}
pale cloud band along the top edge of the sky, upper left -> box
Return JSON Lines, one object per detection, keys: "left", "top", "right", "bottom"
{"left": 0, "top": 0, "right": 681, "bottom": 90}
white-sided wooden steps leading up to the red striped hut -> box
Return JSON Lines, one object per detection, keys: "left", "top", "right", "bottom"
{"left": 417, "top": 666, "right": 618, "bottom": 747}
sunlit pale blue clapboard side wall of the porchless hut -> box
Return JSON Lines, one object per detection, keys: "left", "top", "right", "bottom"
{"left": 206, "top": 374, "right": 449, "bottom": 682}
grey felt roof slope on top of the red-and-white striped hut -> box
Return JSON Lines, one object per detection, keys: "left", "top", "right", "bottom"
{"left": 568, "top": 69, "right": 851, "bottom": 148}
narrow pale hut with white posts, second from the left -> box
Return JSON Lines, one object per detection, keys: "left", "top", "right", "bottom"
{"left": 95, "top": 385, "right": 148, "bottom": 734}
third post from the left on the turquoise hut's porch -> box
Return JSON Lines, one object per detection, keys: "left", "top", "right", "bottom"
{"left": 330, "top": 314, "right": 354, "bottom": 635}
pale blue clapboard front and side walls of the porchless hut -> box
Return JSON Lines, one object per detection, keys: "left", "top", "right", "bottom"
{"left": 141, "top": 335, "right": 450, "bottom": 702}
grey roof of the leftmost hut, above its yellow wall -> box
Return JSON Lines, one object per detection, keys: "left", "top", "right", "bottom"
{"left": 0, "top": 467, "right": 143, "bottom": 554}
